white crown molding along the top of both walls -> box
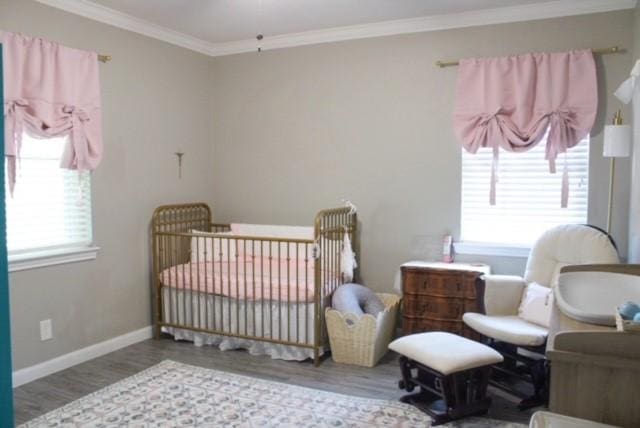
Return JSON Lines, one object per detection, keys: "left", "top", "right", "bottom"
{"left": 36, "top": 0, "right": 638, "bottom": 57}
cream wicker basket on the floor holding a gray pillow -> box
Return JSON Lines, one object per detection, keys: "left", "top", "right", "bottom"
{"left": 325, "top": 293, "right": 400, "bottom": 367}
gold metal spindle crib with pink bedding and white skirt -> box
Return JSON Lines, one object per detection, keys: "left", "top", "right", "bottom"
{"left": 151, "top": 203, "right": 357, "bottom": 366}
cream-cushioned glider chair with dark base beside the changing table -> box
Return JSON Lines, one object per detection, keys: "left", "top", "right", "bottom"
{"left": 463, "top": 225, "right": 619, "bottom": 409}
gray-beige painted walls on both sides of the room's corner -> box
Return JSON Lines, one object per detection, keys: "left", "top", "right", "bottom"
{"left": 0, "top": 0, "right": 633, "bottom": 369}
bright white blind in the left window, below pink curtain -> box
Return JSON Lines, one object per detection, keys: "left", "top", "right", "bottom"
{"left": 5, "top": 134, "right": 92, "bottom": 255}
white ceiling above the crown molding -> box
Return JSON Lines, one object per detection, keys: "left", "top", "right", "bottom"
{"left": 86, "top": 0, "right": 548, "bottom": 43}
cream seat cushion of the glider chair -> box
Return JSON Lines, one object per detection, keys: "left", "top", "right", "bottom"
{"left": 462, "top": 312, "right": 548, "bottom": 346}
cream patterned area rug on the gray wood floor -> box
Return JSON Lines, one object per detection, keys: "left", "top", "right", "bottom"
{"left": 21, "top": 361, "right": 522, "bottom": 428}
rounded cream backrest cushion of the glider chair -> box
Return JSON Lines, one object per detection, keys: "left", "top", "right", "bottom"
{"left": 524, "top": 224, "right": 620, "bottom": 287}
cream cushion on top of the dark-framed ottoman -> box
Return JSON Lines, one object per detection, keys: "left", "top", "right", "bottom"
{"left": 389, "top": 332, "right": 503, "bottom": 375}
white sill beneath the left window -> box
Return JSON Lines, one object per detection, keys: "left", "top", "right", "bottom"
{"left": 9, "top": 246, "right": 100, "bottom": 272}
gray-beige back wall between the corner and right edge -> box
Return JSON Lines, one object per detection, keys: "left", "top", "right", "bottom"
{"left": 211, "top": 12, "right": 633, "bottom": 290}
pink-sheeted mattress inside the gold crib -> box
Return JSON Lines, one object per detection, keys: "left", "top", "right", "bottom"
{"left": 160, "top": 257, "right": 315, "bottom": 303}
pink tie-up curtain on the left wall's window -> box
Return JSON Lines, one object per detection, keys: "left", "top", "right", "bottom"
{"left": 0, "top": 32, "right": 102, "bottom": 192}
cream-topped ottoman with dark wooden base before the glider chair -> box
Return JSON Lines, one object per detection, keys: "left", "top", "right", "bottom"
{"left": 389, "top": 332, "right": 503, "bottom": 425}
